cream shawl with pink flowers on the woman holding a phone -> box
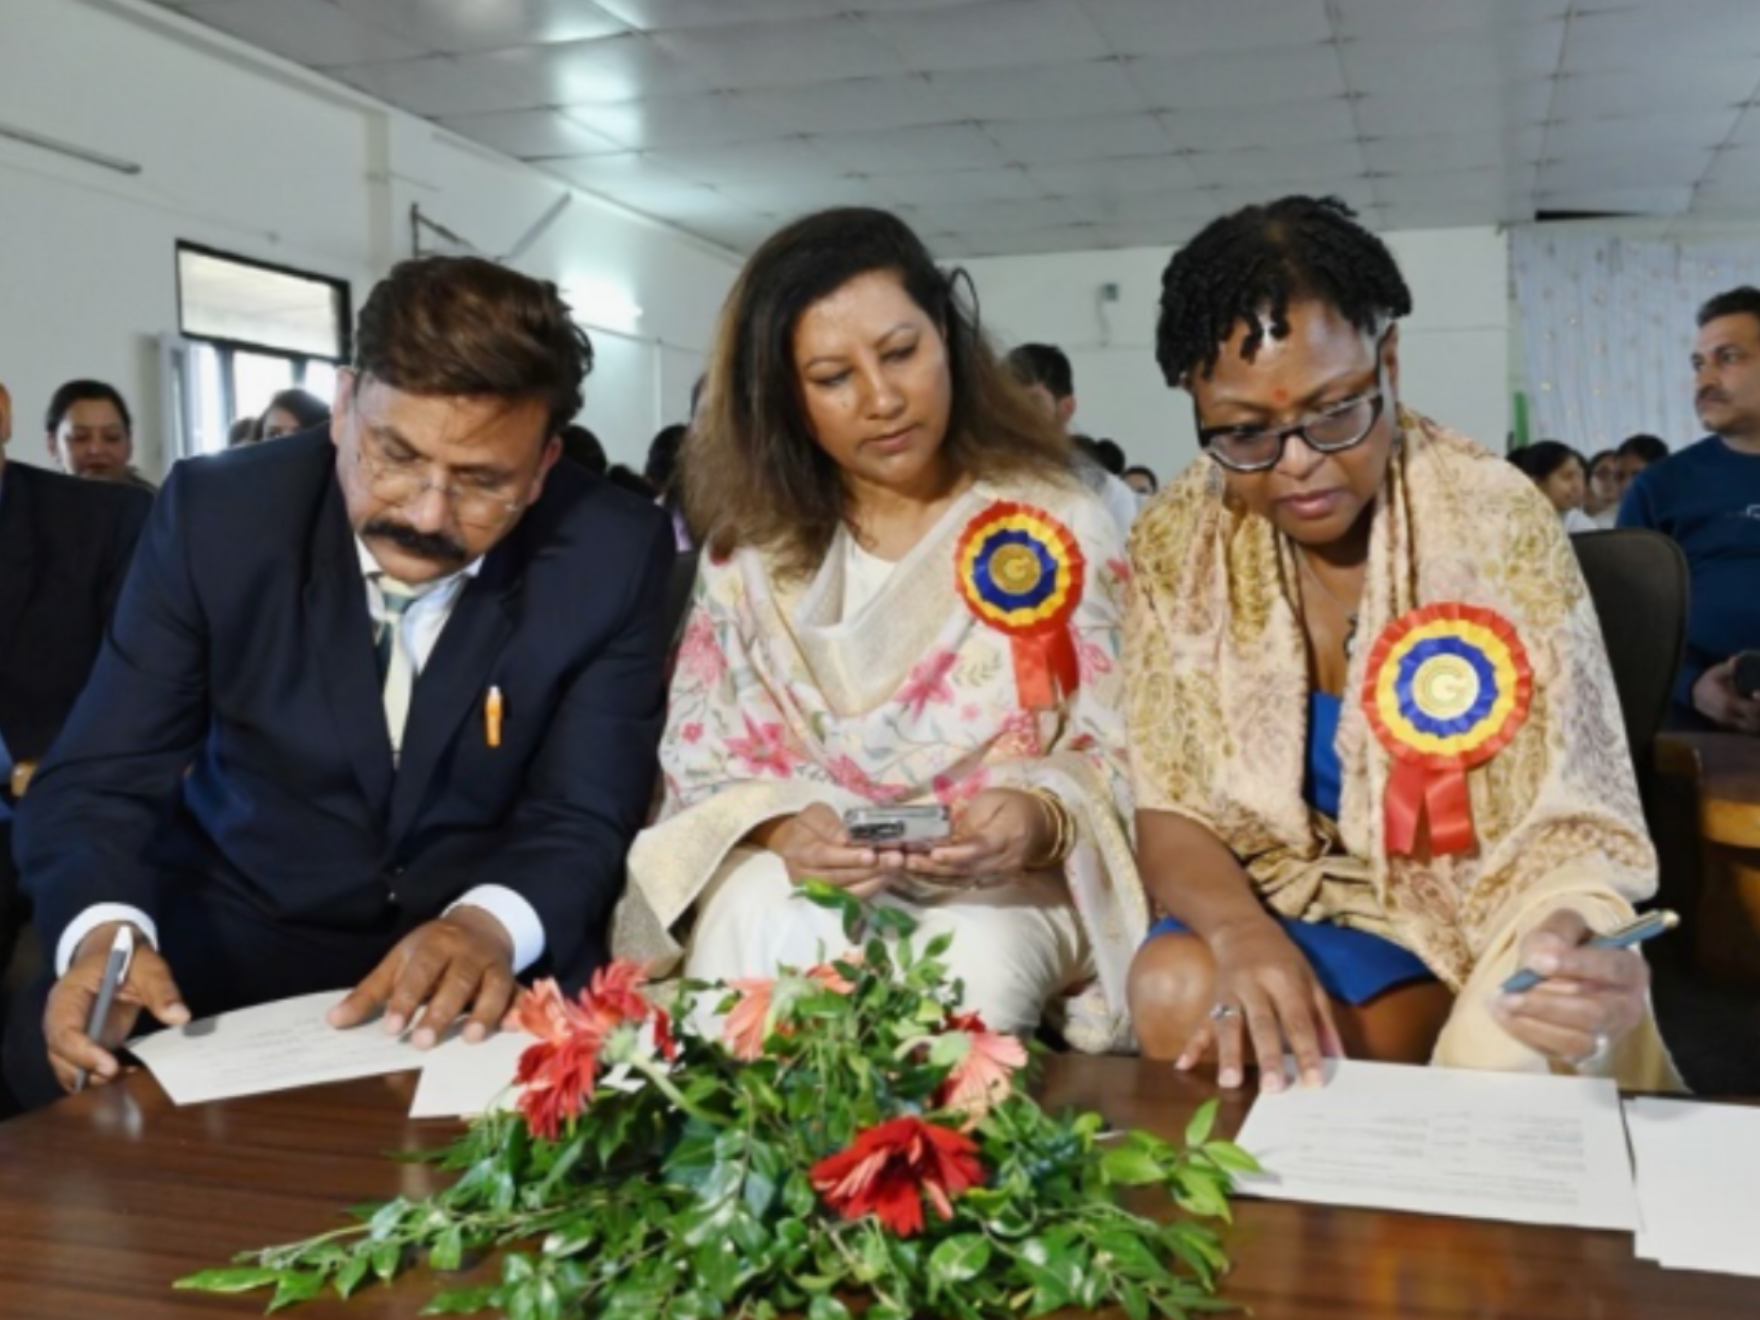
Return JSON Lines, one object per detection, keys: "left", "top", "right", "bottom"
{"left": 612, "top": 482, "right": 1148, "bottom": 1051}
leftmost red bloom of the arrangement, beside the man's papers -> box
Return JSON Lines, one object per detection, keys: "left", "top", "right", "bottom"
{"left": 514, "top": 959, "right": 678, "bottom": 1140}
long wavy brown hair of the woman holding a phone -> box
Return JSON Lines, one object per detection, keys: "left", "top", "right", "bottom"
{"left": 681, "top": 208, "right": 1072, "bottom": 576}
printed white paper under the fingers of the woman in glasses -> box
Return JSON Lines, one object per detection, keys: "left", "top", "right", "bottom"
{"left": 1236, "top": 1060, "right": 1637, "bottom": 1230}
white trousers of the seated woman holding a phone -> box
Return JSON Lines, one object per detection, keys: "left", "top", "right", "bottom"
{"left": 685, "top": 848, "right": 1093, "bottom": 1035}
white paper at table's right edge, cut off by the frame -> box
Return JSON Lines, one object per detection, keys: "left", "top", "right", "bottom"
{"left": 1626, "top": 1098, "right": 1760, "bottom": 1278}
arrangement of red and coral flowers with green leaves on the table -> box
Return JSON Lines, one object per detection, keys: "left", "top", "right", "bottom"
{"left": 178, "top": 885, "right": 1257, "bottom": 1320}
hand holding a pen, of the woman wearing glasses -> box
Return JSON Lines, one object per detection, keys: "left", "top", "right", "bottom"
{"left": 1492, "top": 908, "right": 1649, "bottom": 1065}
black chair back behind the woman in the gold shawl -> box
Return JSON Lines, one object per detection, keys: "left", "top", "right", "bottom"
{"left": 1570, "top": 530, "right": 1688, "bottom": 763}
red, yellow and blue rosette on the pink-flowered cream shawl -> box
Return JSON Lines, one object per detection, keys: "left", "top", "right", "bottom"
{"left": 954, "top": 500, "right": 1088, "bottom": 709}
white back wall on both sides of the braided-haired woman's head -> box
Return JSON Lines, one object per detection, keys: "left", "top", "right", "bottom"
{"left": 963, "top": 229, "right": 1510, "bottom": 480}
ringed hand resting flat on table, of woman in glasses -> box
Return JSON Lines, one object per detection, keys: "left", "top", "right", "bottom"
{"left": 1174, "top": 919, "right": 1345, "bottom": 1091}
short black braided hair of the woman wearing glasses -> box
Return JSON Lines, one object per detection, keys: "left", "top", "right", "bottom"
{"left": 1155, "top": 195, "right": 1412, "bottom": 385}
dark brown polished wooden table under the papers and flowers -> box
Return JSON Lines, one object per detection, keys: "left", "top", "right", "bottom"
{"left": 0, "top": 1058, "right": 1760, "bottom": 1320}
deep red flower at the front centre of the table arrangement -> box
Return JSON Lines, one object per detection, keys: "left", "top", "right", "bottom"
{"left": 811, "top": 1116, "right": 984, "bottom": 1237}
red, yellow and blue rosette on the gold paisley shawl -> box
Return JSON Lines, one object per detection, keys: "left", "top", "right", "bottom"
{"left": 1362, "top": 602, "right": 1533, "bottom": 855}
